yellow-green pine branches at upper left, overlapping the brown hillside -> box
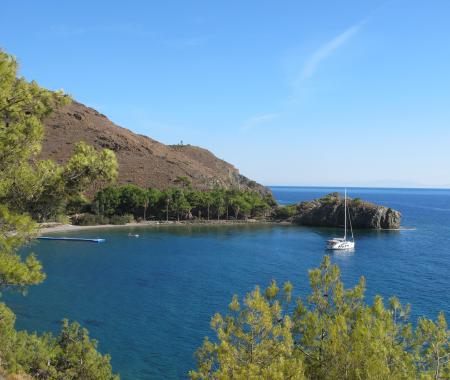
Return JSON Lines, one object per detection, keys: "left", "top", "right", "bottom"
{"left": 0, "top": 51, "right": 117, "bottom": 221}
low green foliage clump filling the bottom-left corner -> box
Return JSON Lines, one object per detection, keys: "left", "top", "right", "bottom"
{"left": 0, "top": 303, "right": 119, "bottom": 380}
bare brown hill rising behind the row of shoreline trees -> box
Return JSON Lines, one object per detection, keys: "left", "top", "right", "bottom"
{"left": 41, "top": 102, "right": 268, "bottom": 193}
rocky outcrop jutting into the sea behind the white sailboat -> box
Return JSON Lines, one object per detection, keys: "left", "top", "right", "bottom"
{"left": 291, "top": 193, "right": 401, "bottom": 230}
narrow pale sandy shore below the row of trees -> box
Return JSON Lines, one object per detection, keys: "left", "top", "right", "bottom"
{"left": 39, "top": 219, "right": 284, "bottom": 235}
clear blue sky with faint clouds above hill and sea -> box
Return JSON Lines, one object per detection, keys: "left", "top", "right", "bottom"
{"left": 0, "top": 0, "right": 450, "bottom": 187}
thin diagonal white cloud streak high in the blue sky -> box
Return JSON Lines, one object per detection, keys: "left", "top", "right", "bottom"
{"left": 300, "top": 20, "right": 365, "bottom": 81}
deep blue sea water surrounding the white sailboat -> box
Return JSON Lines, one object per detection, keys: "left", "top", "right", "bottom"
{"left": 4, "top": 187, "right": 450, "bottom": 380}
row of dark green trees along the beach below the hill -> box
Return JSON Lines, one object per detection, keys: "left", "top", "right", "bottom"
{"left": 72, "top": 181, "right": 276, "bottom": 224}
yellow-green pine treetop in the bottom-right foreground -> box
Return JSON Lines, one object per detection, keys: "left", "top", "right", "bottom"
{"left": 190, "top": 256, "right": 450, "bottom": 380}
